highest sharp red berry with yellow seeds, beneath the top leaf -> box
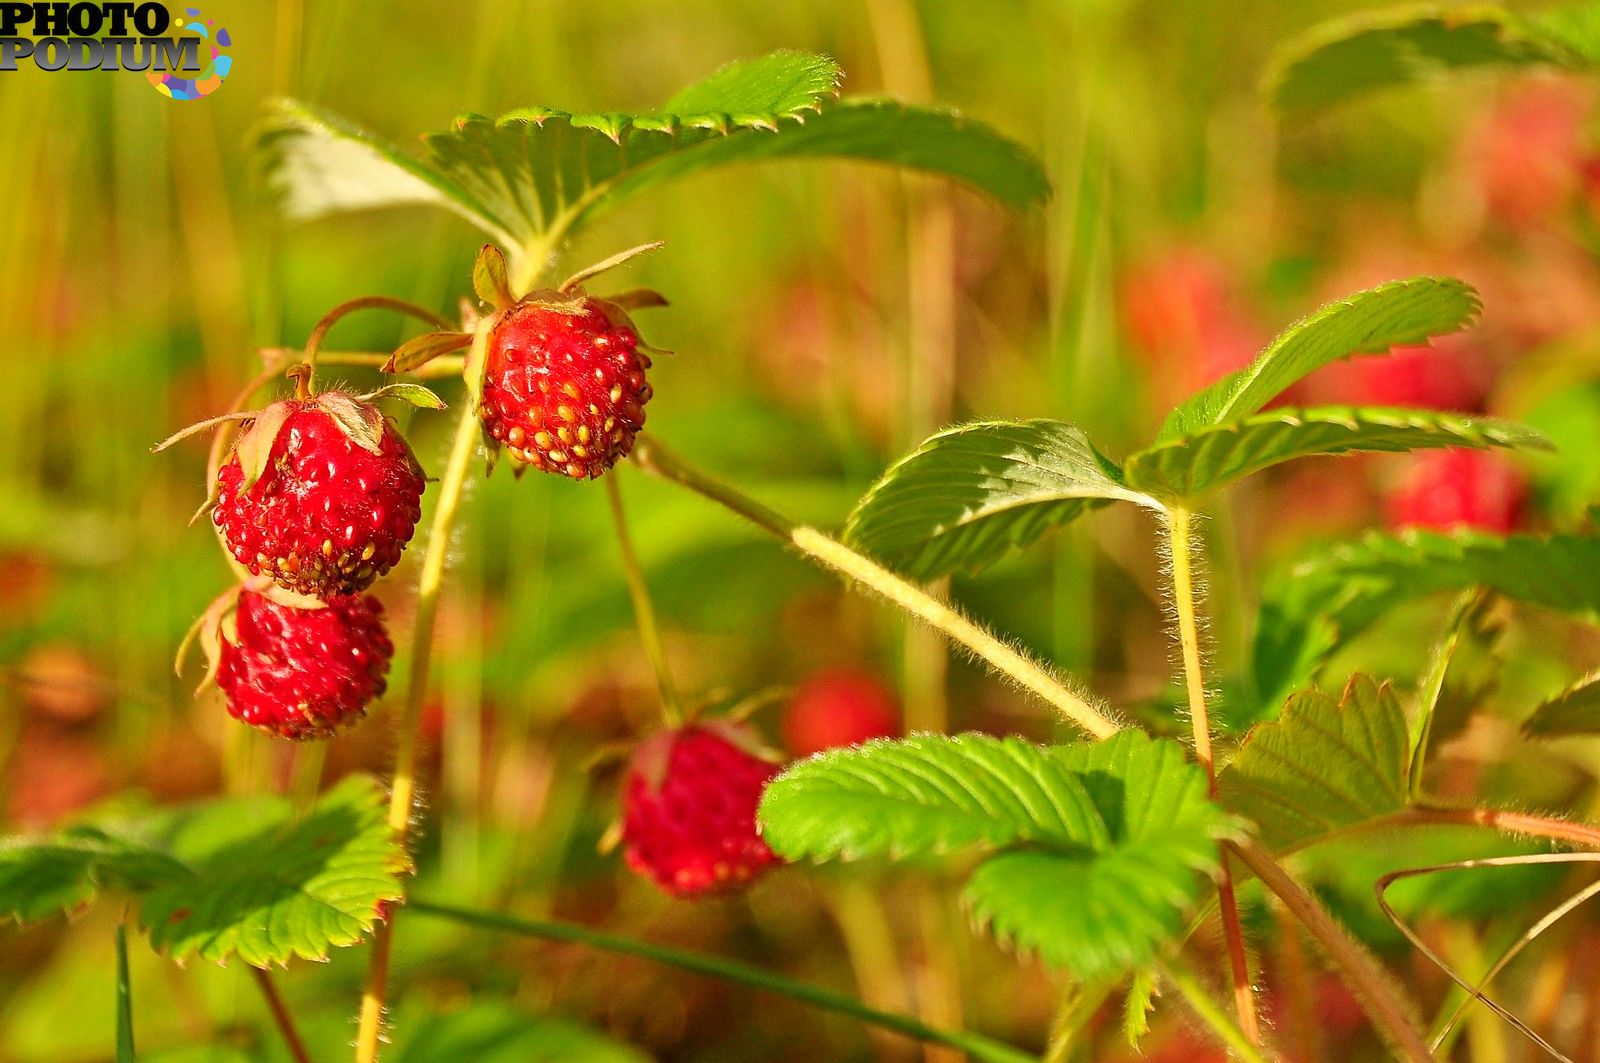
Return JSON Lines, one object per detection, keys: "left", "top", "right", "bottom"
{"left": 480, "top": 293, "right": 653, "bottom": 480}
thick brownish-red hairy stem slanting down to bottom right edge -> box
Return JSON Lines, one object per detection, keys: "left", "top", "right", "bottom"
{"left": 1229, "top": 840, "right": 1434, "bottom": 1063}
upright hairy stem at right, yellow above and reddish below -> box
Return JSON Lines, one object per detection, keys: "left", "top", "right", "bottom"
{"left": 1166, "top": 506, "right": 1261, "bottom": 1044}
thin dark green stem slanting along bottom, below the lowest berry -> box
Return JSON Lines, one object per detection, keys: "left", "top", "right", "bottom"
{"left": 408, "top": 901, "right": 1032, "bottom": 1063}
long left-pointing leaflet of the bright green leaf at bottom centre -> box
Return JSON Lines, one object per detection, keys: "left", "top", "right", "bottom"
{"left": 760, "top": 735, "right": 1109, "bottom": 860}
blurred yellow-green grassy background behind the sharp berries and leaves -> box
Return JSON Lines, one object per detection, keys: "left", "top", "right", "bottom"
{"left": 0, "top": 0, "right": 1600, "bottom": 1061}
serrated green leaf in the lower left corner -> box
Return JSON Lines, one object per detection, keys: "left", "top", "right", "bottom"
{"left": 0, "top": 775, "right": 410, "bottom": 967}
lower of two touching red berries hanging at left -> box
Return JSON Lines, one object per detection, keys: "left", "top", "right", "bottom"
{"left": 216, "top": 591, "right": 395, "bottom": 738}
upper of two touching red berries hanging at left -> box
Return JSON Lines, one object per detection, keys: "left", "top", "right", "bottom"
{"left": 211, "top": 392, "right": 424, "bottom": 599}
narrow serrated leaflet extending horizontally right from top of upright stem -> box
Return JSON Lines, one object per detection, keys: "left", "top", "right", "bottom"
{"left": 1123, "top": 407, "right": 1549, "bottom": 496}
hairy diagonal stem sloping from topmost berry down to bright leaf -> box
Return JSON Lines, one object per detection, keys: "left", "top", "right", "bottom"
{"left": 634, "top": 440, "right": 1120, "bottom": 738}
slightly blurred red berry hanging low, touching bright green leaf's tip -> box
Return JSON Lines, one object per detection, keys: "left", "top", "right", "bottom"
{"left": 622, "top": 724, "right": 778, "bottom": 900}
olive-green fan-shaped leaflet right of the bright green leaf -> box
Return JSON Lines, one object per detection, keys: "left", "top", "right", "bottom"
{"left": 1218, "top": 676, "right": 1411, "bottom": 850}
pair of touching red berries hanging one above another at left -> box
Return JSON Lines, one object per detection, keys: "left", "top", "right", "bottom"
{"left": 168, "top": 382, "right": 437, "bottom": 740}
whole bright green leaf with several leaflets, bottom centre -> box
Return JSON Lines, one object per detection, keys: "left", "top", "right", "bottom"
{"left": 760, "top": 730, "right": 1232, "bottom": 978}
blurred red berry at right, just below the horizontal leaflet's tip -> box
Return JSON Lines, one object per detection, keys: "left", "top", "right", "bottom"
{"left": 1389, "top": 450, "right": 1528, "bottom": 535}
